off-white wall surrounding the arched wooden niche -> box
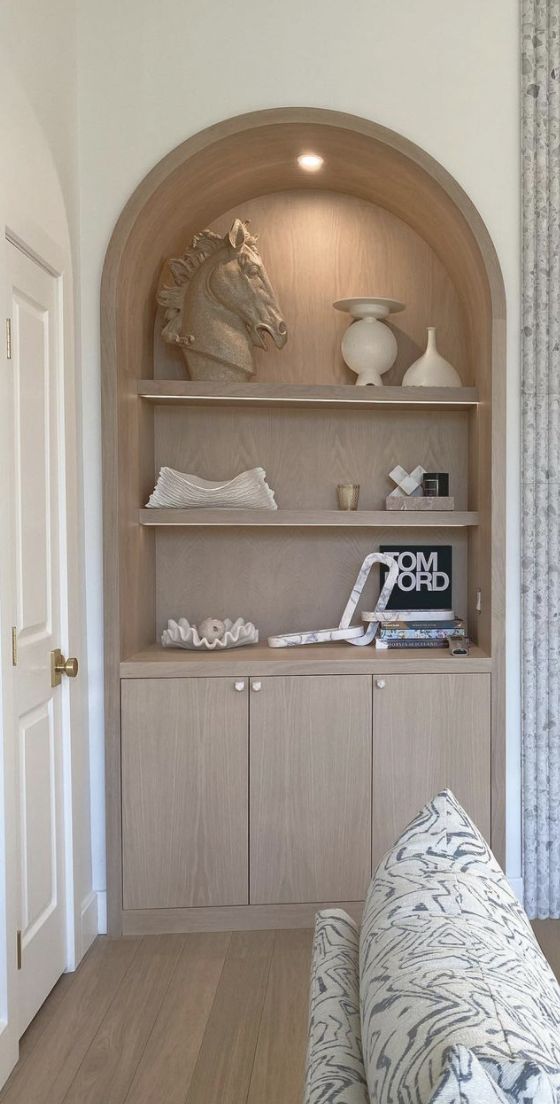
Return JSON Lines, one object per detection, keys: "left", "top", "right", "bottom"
{"left": 78, "top": 0, "right": 520, "bottom": 888}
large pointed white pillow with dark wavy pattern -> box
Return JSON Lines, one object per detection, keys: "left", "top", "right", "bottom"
{"left": 360, "top": 790, "right": 560, "bottom": 1104}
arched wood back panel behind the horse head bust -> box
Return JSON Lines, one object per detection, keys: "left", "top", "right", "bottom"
{"left": 154, "top": 190, "right": 473, "bottom": 385}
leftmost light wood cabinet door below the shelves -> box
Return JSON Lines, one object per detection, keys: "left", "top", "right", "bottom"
{"left": 121, "top": 679, "right": 249, "bottom": 909}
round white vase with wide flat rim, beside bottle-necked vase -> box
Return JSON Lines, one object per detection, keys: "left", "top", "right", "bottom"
{"left": 334, "top": 298, "right": 404, "bottom": 388}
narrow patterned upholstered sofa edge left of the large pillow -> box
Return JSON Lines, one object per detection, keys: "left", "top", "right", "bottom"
{"left": 305, "top": 909, "right": 368, "bottom": 1104}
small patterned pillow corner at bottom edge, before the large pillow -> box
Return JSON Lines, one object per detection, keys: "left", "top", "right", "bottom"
{"left": 430, "top": 1047, "right": 557, "bottom": 1104}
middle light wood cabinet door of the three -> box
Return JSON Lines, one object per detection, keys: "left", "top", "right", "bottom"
{"left": 250, "top": 675, "right": 371, "bottom": 904}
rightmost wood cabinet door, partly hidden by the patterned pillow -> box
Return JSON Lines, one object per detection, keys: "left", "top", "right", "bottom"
{"left": 373, "top": 675, "right": 490, "bottom": 869}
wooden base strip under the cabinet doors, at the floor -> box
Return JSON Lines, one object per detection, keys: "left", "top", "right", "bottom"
{"left": 119, "top": 901, "right": 363, "bottom": 935}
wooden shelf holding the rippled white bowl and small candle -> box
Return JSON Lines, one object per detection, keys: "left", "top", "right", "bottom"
{"left": 138, "top": 508, "right": 478, "bottom": 529}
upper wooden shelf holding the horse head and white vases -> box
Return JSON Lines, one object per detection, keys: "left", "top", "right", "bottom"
{"left": 137, "top": 380, "right": 478, "bottom": 410}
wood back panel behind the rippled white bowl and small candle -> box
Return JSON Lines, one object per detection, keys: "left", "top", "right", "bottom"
{"left": 152, "top": 406, "right": 469, "bottom": 507}
